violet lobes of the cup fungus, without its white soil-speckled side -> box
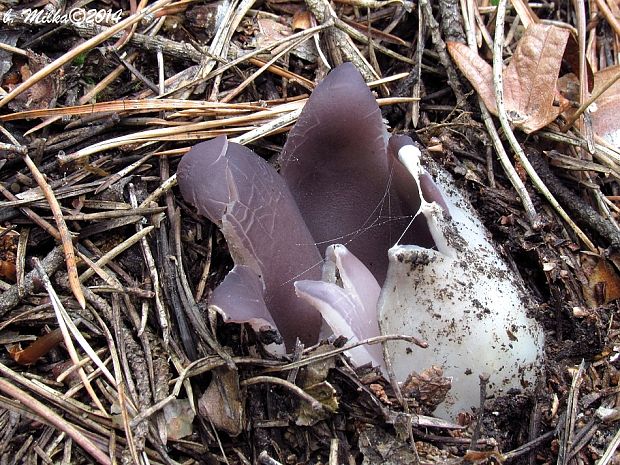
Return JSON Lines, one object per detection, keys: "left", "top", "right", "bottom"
{"left": 177, "top": 63, "right": 440, "bottom": 348}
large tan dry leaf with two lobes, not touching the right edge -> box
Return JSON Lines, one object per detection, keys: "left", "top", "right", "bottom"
{"left": 448, "top": 24, "right": 570, "bottom": 134}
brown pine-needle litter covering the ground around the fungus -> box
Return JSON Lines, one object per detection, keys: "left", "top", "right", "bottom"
{"left": 0, "top": 1, "right": 620, "bottom": 465}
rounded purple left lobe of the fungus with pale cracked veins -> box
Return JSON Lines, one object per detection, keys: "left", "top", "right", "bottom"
{"left": 177, "top": 136, "right": 322, "bottom": 348}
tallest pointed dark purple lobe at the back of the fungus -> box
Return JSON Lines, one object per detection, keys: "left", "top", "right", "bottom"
{"left": 280, "top": 63, "right": 416, "bottom": 283}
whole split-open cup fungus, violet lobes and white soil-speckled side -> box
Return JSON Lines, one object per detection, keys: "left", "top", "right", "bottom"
{"left": 178, "top": 60, "right": 543, "bottom": 417}
